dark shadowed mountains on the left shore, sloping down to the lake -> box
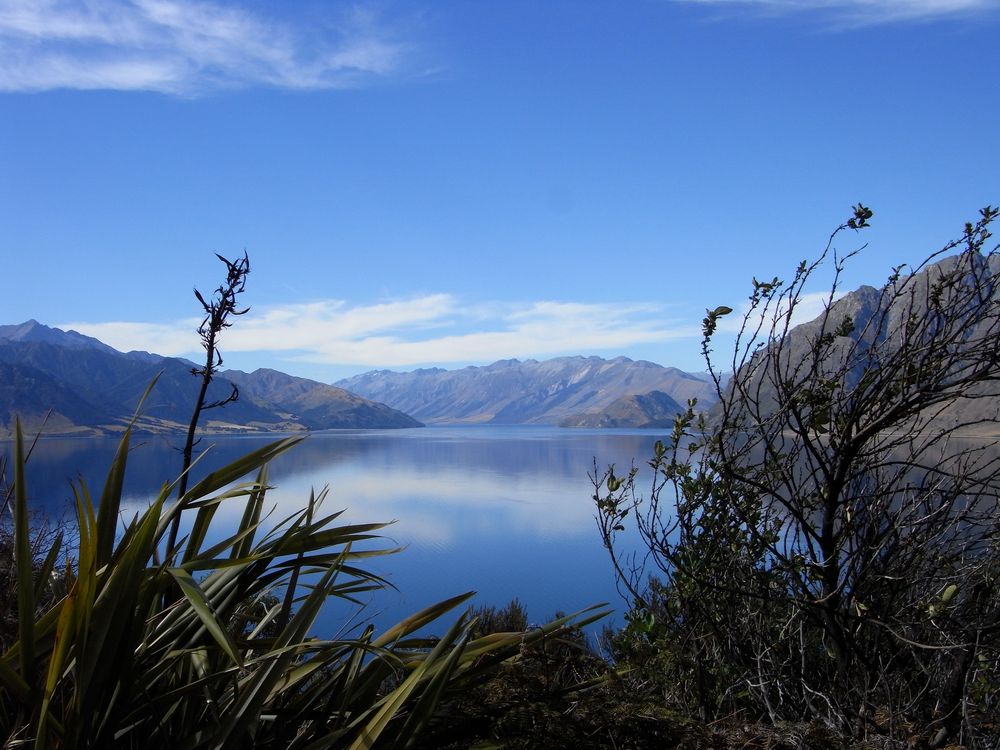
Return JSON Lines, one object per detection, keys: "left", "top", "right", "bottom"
{"left": 0, "top": 321, "right": 419, "bottom": 435}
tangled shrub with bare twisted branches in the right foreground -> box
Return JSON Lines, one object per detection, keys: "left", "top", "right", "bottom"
{"left": 595, "top": 205, "right": 1000, "bottom": 747}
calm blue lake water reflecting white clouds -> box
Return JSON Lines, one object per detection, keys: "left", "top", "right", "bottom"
{"left": 0, "top": 426, "right": 660, "bottom": 634}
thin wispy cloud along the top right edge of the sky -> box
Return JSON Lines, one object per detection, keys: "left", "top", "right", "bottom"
{"left": 674, "top": 0, "right": 1000, "bottom": 26}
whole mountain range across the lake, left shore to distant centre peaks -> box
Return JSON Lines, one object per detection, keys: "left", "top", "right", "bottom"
{"left": 0, "top": 320, "right": 713, "bottom": 437}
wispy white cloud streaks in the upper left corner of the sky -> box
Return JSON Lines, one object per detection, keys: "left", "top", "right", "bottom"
{"left": 0, "top": 0, "right": 412, "bottom": 95}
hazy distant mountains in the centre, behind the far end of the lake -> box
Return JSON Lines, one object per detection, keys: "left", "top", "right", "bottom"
{"left": 336, "top": 357, "right": 714, "bottom": 426}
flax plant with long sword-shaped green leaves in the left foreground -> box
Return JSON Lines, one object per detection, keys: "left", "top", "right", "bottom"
{"left": 0, "top": 414, "right": 603, "bottom": 750}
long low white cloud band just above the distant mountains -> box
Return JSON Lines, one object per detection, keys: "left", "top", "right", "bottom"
{"left": 59, "top": 294, "right": 699, "bottom": 374}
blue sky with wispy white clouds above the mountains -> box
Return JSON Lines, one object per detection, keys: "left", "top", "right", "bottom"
{"left": 0, "top": 0, "right": 1000, "bottom": 381}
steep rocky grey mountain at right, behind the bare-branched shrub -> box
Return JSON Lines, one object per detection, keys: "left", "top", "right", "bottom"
{"left": 724, "top": 254, "right": 1000, "bottom": 435}
